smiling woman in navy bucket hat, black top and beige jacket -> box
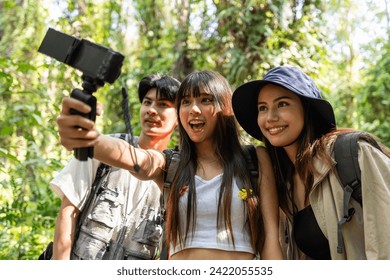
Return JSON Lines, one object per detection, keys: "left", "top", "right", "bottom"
{"left": 232, "top": 66, "right": 390, "bottom": 259}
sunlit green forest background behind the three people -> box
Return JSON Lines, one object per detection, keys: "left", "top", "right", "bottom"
{"left": 0, "top": 0, "right": 390, "bottom": 260}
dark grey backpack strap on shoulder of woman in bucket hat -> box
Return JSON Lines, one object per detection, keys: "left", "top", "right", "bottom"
{"left": 334, "top": 131, "right": 381, "bottom": 254}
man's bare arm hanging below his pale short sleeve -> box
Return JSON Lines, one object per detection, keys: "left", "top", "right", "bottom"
{"left": 52, "top": 196, "right": 80, "bottom": 260}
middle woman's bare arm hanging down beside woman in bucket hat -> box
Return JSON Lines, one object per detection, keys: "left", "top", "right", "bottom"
{"left": 256, "top": 147, "right": 283, "bottom": 260}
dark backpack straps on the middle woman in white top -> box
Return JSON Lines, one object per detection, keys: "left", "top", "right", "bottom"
{"left": 160, "top": 145, "right": 259, "bottom": 260}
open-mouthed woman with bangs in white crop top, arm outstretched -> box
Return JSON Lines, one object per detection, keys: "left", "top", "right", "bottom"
{"left": 57, "top": 71, "right": 282, "bottom": 260}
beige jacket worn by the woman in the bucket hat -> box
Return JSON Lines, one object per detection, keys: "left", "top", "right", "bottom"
{"left": 287, "top": 141, "right": 390, "bottom": 260}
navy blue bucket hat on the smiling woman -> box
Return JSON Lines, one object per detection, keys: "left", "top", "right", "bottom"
{"left": 232, "top": 66, "right": 336, "bottom": 140}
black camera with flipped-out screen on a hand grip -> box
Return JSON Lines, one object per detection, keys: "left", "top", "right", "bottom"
{"left": 38, "top": 28, "right": 124, "bottom": 161}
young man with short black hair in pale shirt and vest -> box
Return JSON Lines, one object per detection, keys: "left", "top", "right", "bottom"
{"left": 51, "top": 74, "right": 180, "bottom": 259}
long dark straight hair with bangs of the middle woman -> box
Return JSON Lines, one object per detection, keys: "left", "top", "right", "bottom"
{"left": 167, "top": 71, "right": 264, "bottom": 252}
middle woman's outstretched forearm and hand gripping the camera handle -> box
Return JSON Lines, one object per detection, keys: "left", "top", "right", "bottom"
{"left": 57, "top": 97, "right": 165, "bottom": 183}
